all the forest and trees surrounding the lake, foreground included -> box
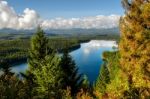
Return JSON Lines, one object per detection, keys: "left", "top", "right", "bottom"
{"left": 0, "top": 0, "right": 150, "bottom": 99}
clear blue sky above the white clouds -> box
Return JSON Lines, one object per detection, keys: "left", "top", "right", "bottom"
{"left": 7, "top": 0, "right": 123, "bottom": 19}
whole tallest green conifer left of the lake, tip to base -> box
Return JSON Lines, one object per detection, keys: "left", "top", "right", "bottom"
{"left": 27, "top": 28, "right": 62, "bottom": 99}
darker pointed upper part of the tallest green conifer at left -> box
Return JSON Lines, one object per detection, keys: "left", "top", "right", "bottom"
{"left": 28, "top": 27, "right": 52, "bottom": 71}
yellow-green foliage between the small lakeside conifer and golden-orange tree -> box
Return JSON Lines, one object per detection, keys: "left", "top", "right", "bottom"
{"left": 104, "top": 52, "right": 128, "bottom": 98}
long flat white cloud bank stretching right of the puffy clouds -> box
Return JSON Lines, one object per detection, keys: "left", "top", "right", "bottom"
{"left": 42, "top": 15, "right": 120, "bottom": 29}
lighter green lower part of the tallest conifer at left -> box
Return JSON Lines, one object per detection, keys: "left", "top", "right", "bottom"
{"left": 35, "top": 56, "right": 62, "bottom": 99}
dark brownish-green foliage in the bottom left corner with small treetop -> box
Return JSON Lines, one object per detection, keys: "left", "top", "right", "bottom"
{"left": 0, "top": 63, "right": 26, "bottom": 99}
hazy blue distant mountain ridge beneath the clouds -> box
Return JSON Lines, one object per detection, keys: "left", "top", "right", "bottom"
{"left": 0, "top": 28, "right": 120, "bottom": 35}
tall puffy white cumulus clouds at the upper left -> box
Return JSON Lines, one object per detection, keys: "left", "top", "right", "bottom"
{"left": 0, "top": 1, "right": 39, "bottom": 29}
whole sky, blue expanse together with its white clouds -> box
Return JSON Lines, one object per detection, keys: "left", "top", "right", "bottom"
{"left": 0, "top": 0, "right": 124, "bottom": 29}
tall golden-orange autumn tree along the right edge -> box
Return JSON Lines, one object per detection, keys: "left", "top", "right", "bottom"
{"left": 119, "top": 0, "right": 150, "bottom": 98}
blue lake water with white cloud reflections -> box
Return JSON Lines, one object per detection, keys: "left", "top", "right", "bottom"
{"left": 11, "top": 40, "right": 117, "bottom": 82}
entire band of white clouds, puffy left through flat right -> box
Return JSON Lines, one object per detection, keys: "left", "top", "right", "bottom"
{"left": 0, "top": 1, "right": 120, "bottom": 29}
